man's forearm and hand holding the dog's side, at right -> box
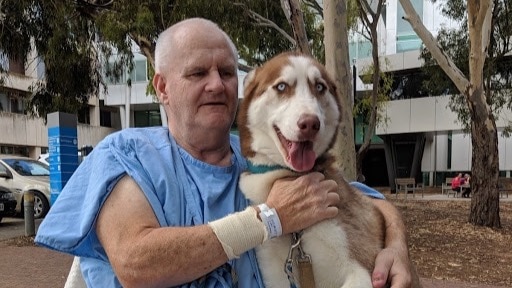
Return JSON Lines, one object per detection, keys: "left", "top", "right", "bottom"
{"left": 372, "top": 199, "right": 414, "bottom": 288}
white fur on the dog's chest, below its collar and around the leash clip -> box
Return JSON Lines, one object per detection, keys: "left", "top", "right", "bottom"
{"left": 240, "top": 170, "right": 372, "bottom": 288}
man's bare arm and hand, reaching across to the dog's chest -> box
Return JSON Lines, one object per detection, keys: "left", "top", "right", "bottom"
{"left": 96, "top": 173, "right": 339, "bottom": 287}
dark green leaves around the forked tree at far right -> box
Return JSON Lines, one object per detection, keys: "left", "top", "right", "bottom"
{"left": 421, "top": 0, "right": 512, "bottom": 131}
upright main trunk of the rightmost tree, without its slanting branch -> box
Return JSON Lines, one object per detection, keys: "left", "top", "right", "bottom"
{"left": 466, "top": 0, "right": 501, "bottom": 228}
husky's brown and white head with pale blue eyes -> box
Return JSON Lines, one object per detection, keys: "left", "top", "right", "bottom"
{"left": 238, "top": 52, "right": 340, "bottom": 172}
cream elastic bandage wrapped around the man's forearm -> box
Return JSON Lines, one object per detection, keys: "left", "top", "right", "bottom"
{"left": 208, "top": 207, "right": 268, "bottom": 260}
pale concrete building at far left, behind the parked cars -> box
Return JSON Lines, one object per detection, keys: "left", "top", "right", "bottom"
{"left": 0, "top": 47, "right": 120, "bottom": 159}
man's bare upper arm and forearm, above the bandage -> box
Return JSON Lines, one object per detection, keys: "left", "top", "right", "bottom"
{"left": 96, "top": 176, "right": 228, "bottom": 287}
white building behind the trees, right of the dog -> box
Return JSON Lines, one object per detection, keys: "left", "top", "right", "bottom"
{"left": 349, "top": 0, "right": 512, "bottom": 186}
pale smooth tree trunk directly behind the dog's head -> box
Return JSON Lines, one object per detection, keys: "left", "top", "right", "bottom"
{"left": 324, "top": 0, "right": 356, "bottom": 181}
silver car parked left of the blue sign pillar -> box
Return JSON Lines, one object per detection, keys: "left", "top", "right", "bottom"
{"left": 0, "top": 155, "right": 50, "bottom": 218}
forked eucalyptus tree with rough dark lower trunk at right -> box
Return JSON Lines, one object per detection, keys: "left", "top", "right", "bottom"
{"left": 400, "top": 0, "right": 504, "bottom": 228}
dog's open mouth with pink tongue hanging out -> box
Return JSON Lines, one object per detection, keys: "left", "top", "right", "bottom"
{"left": 274, "top": 127, "right": 316, "bottom": 172}
